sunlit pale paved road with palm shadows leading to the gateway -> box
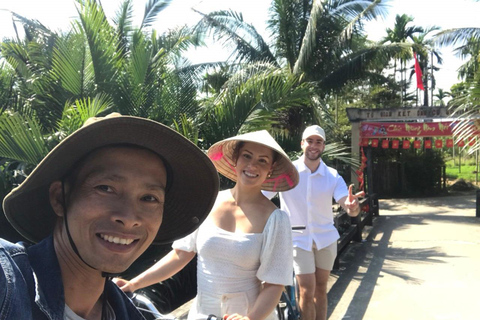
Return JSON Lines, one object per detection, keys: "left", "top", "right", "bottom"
{"left": 174, "top": 193, "right": 480, "bottom": 320}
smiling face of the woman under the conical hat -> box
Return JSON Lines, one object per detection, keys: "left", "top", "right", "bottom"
{"left": 236, "top": 142, "right": 274, "bottom": 186}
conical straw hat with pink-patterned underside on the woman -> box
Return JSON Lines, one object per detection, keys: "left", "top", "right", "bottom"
{"left": 207, "top": 130, "right": 299, "bottom": 192}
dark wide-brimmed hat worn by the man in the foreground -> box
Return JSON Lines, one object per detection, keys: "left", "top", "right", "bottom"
{"left": 3, "top": 114, "right": 219, "bottom": 244}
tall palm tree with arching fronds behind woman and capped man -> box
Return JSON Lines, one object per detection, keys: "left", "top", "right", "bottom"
{"left": 193, "top": 0, "right": 403, "bottom": 146}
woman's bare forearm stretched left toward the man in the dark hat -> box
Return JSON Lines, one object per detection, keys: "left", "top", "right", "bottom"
{"left": 116, "top": 249, "right": 195, "bottom": 292}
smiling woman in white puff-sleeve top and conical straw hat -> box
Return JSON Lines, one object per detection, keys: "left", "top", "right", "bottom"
{"left": 119, "top": 130, "right": 298, "bottom": 320}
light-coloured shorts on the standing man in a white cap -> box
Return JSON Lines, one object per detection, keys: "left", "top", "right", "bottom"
{"left": 293, "top": 241, "right": 337, "bottom": 274}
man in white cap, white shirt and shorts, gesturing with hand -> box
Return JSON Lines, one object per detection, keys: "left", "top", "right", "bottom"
{"left": 264, "top": 125, "right": 364, "bottom": 320}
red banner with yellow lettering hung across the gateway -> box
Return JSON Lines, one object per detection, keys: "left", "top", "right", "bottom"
{"left": 360, "top": 121, "right": 452, "bottom": 138}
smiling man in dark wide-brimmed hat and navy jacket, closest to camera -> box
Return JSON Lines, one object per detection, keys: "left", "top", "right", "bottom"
{"left": 0, "top": 114, "right": 218, "bottom": 320}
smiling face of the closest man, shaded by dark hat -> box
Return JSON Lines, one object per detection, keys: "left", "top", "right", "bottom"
{"left": 52, "top": 147, "right": 167, "bottom": 273}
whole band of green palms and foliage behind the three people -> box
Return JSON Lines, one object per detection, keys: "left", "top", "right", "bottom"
{"left": 0, "top": 0, "right": 480, "bottom": 198}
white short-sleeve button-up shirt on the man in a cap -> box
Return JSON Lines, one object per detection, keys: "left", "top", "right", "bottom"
{"left": 274, "top": 155, "right": 348, "bottom": 251}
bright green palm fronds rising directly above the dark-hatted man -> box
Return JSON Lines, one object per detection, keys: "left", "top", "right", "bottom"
{"left": 0, "top": 0, "right": 202, "bottom": 180}
